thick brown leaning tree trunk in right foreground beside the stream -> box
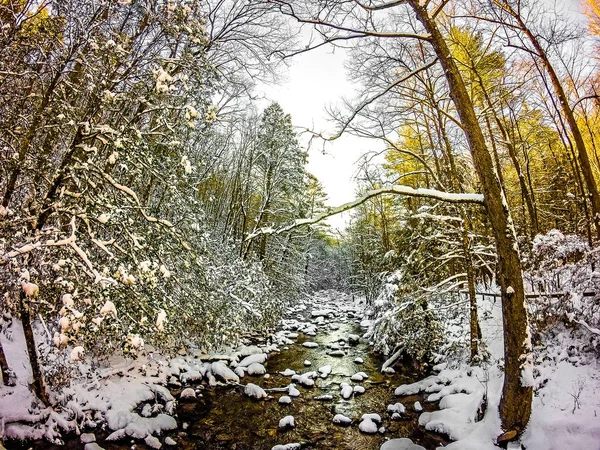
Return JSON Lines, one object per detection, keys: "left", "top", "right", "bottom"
{"left": 410, "top": 5, "right": 532, "bottom": 436}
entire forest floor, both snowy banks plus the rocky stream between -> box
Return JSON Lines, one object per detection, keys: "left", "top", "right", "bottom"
{"left": 0, "top": 291, "right": 600, "bottom": 450}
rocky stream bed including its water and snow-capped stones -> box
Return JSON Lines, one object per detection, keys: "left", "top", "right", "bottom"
{"left": 9, "top": 293, "right": 448, "bottom": 450}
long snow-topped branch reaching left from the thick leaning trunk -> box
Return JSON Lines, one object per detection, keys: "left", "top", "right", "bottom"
{"left": 245, "top": 185, "right": 483, "bottom": 241}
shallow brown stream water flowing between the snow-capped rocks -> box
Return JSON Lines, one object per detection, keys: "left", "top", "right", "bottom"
{"left": 7, "top": 294, "right": 448, "bottom": 450}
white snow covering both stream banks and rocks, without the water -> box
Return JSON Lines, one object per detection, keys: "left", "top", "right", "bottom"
{"left": 0, "top": 293, "right": 600, "bottom": 450}
